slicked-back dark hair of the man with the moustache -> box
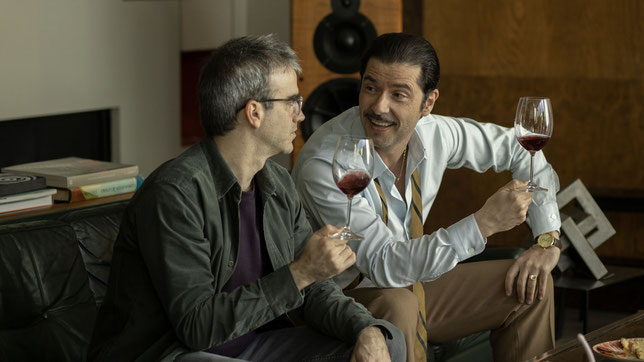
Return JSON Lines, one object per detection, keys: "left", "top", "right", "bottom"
{"left": 360, "top": 33, "right": 440, "bottom": 95}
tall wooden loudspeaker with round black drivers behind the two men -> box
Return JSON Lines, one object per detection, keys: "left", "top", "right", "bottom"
{"left": 291, "top": 0, "right": 402, "bottom": 162}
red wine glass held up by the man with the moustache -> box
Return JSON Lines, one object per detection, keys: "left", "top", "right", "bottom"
{"left": 514, "top": 97, "right": 553, "bottom": 192}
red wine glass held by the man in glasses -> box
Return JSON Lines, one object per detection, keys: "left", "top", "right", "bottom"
{"left": 331, "top": 136, "right": 374, "bottom": 240}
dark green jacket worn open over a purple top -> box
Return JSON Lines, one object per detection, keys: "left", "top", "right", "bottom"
{"left": 89, "top": 139, "right": 380, "bottom": 361}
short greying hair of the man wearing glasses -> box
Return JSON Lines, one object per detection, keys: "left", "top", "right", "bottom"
{"left": 198, "top": 34, "right": 302, "bottom": 137}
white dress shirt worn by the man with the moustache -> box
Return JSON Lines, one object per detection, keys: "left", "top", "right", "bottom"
{"left": 292, "top": 107, "right": 561, "bottom": 288}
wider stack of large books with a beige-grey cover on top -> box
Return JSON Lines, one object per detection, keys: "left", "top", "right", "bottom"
{"left": 2, "top": 157, "right": 143, "bottom": 206}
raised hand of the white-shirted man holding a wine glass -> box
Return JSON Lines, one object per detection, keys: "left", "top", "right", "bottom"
{"left": 474, "top": 180, "right": 532, "bottom": 238}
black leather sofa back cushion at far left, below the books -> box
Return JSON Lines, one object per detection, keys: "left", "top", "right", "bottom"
{"left": 0, "top": 220, "right": 96, "bottom": 361}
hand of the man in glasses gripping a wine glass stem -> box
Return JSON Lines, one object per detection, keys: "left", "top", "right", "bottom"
{"left": 289, "top": 225, "right": 356, "bottom": 290}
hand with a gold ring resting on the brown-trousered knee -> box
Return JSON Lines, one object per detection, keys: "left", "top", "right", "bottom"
{"left": 505, "top": 231, "right": 561, "bottom": 304}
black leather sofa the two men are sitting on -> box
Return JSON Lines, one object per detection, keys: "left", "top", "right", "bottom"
{"left": 0, "top": 200, "right": 521, "bottom": 362}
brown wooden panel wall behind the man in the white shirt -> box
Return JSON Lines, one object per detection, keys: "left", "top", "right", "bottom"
{"left": 423, "top": 0, "right": 644, "bottom": 261}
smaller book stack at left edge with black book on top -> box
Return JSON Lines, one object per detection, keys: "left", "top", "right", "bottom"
{"left": 0, "top": 172, "right": 56, "bottom": 215}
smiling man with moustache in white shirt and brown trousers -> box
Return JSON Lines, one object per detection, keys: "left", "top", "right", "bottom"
{"left": 292, "top": 34, "right": 561, "bottom": 361}
